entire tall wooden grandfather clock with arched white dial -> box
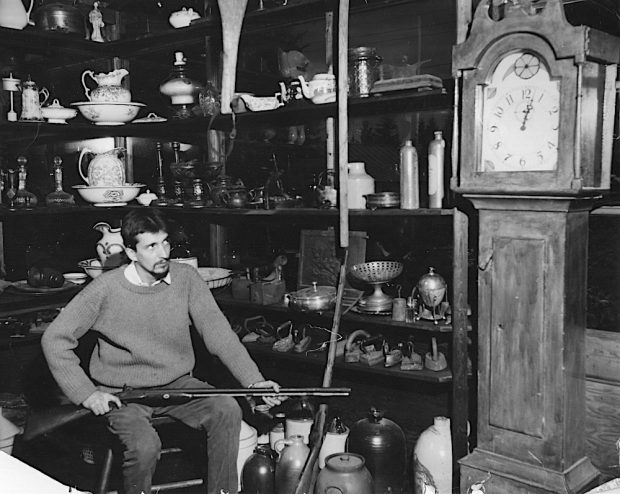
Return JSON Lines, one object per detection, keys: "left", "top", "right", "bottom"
{"left": 452, "top": 0, "right": 620, "bottom": 494}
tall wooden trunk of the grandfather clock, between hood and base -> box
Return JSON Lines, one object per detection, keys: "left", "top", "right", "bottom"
{"left": 474, "top": 205, "right": 587, "bottom": 470}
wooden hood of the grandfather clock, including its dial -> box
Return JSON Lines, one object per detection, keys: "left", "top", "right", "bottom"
{"left": 452, "top": 0, "right": 620, "bottom": 196}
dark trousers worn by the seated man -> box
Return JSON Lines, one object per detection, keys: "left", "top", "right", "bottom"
{"left": 106, "top": 376, "right": 241, "bottom": 494}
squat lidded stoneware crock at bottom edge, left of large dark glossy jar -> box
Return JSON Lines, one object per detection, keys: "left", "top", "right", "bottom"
{"left": 314, "top": 453, "right": 373, "bottom": 494}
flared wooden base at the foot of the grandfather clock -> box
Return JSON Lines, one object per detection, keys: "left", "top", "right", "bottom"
{"left": 459, "top": 448, "right": 600, "bottom": 494}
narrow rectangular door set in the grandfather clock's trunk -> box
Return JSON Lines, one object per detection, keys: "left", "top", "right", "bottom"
{"left": 489, "top": 237, "right": 545, "bottom": 437}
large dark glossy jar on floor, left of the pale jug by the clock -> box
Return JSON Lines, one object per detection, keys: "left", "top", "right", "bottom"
{"left": 348, "top": 408, "right": 407, "bottom": 494}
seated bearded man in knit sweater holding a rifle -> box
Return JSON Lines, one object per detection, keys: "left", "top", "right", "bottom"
{"left": 42, "top": 208, "right": 279, "bottom": 494}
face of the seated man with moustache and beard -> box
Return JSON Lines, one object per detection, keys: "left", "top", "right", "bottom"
{"left": 127, "top": 232, "right": 170, "bottom": 283}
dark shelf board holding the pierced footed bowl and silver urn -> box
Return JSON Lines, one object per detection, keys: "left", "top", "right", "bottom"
{"left": 214, "top": 291, "right": 460, "bottom": 335}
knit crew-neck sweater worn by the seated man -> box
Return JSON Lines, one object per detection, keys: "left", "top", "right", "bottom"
{"left": 41, "top": 263, "right": 264, "bottom": 404}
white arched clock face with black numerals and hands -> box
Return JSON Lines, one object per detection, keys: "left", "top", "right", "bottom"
{"left": 479, "top": 50, "right": 560, "bottom": 172}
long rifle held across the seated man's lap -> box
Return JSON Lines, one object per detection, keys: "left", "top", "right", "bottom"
{"left": 24, "top": 388, "right": 351, "bottom": 441}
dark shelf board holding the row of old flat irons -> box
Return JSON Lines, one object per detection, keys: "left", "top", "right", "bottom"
{"left": 244, "top": 343, "right": 452, "bottom": 383}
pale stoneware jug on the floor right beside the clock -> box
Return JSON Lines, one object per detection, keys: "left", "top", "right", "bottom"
{"left": 413, "top": 417, "right": 452, "bottom": 494}
